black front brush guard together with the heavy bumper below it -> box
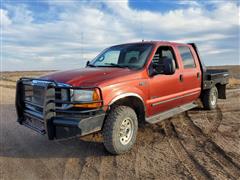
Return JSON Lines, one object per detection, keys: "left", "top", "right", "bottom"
{"left": 16, "top": 78, "right": 105, "bottom": 140}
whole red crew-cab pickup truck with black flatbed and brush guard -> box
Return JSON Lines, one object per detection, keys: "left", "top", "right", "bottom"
{"left": 16, "top": 41, "right": 229, "bottom": 154}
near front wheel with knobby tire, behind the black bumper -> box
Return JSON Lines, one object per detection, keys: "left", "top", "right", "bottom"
{"left": 103, "top": 106, "right": 138, "bottom": 154}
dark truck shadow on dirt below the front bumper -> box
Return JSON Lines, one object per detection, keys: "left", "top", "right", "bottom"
{"left": 0, "top": 132, "right": 110, "bottom": 159}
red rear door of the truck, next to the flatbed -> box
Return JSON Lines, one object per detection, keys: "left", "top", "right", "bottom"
{"left": 177, "top": 45, "right": 202, "bottom": 104}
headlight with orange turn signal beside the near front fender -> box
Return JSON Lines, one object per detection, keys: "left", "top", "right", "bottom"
{"left": 71, "top": 89, "right": 101, "bottom": 108}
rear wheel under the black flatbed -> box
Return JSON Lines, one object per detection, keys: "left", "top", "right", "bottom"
{"left": 202, "top": 86, "right": 218, "bottom": 110}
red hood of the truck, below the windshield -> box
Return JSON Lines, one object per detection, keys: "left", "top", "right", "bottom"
{"left": 40, "top": 67, "right": 142, "bottom": 86}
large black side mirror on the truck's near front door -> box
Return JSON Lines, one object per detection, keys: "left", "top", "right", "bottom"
{"left": 149, "top": 56, "right": 176, "bottom": 77}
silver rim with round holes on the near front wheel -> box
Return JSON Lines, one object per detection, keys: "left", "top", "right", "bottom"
{"left": 119, "top": 117, "right": 133, "bottom": 145}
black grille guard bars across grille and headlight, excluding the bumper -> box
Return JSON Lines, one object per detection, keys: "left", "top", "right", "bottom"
{"left": 16, "top": 77, "right": 103, "bottom": 139}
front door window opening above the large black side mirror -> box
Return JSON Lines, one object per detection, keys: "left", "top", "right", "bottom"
{"left": 152, "top": 46, "right": 178, "bottom": 69}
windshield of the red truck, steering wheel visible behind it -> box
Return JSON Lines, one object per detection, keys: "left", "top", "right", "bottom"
{"left": 89, "top": 43, "right": 152, "bottom": 69}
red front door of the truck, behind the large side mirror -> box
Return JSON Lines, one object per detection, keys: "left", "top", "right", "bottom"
{"left": 147, "top": 46, "right": 182, "bottom": 116}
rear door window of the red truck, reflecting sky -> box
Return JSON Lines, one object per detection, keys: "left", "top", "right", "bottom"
{"left": 178, "top": 46, "right": 196, "bottom": 69}
